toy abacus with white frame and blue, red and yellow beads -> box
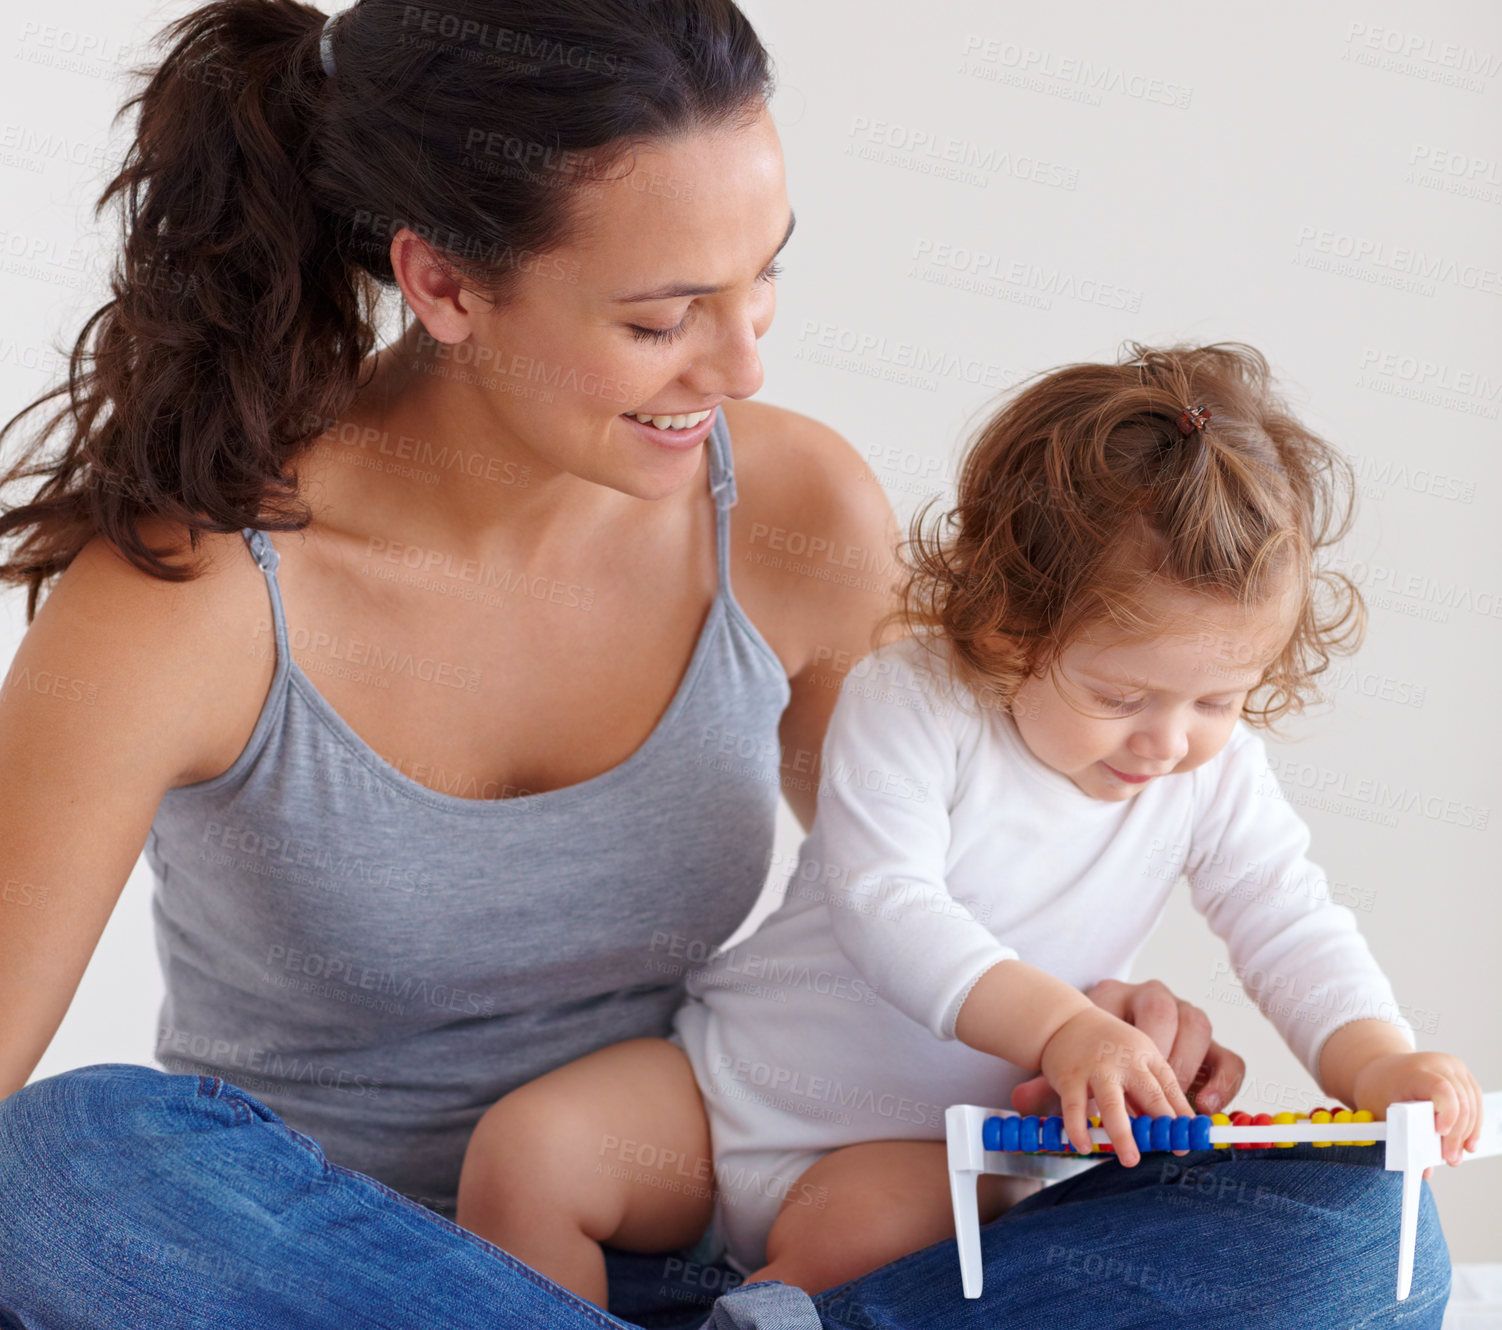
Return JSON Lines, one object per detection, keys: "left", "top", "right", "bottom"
{"left": 945, "top": 1091, "right": 1502, "bottom": 1301}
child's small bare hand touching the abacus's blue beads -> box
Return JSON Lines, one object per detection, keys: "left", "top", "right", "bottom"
{"left": 1042, "top": 1007, "right": 1193, "bottom": 1168}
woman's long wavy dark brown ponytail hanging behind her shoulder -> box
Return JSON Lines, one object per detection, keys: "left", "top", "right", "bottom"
{"left": 0, "top": 0, "right": 374, "bottom": 619}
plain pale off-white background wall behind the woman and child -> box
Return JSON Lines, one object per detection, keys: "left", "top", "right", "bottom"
{"left": 0, "top": 0, "right": 1502, "bottom": 1262}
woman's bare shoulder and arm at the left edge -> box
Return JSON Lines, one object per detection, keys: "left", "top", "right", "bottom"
{"left": 0, "top": 522, "right": 272, "bottom": 1099}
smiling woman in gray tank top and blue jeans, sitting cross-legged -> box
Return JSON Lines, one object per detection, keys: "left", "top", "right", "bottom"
{"left": 0, "top": 0, "right": 1448, "bottom": 1327}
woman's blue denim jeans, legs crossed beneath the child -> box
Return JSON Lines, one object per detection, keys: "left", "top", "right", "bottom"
{"left": 0, "top": 1064, "right": 1449, "bottom": 1330}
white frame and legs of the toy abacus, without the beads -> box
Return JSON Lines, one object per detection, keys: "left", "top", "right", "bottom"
{"left": 945, "top": 1091, "right": 1502, "bottom": 1301}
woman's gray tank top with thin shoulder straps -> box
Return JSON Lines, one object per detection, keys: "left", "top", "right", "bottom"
{"left": 146, "top": 415, "right": 789, "bottom": 1217}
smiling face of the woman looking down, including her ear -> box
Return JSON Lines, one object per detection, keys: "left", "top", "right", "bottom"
{"left": 405, "top": 102, "right": 792, "bottom": 499}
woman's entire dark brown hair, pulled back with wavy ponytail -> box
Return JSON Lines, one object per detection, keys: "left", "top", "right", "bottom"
{"left": 0, "top": 0, "right": 771, "bottom": 622}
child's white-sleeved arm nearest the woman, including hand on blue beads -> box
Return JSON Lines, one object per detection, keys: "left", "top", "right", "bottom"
{"left": 811, "top": 643, "right": 1191, "bottom": 1163}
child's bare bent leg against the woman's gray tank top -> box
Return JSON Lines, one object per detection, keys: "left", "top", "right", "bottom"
{"left": 457, "top": 1038, "right": 713, "bottom": 1307}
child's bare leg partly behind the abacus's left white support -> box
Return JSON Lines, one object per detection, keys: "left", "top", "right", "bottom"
{"left": 746, "top": 1141, "right": 1042, "bottom": 1294}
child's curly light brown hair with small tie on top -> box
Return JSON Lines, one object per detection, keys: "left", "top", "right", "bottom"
{"left": 883, "top": 343, "right": 1365, "bottom": 727}
